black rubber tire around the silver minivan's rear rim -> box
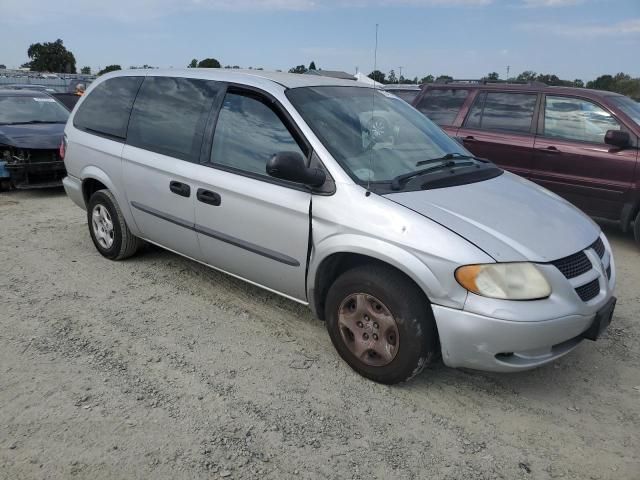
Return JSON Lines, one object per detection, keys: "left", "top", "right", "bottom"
{"left": 87, "top": 189, "right": 142, "bottom": 260}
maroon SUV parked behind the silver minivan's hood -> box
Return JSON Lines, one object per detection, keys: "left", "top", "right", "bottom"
{"left": 413, "top": 82, "right": 640, "bottom": 242}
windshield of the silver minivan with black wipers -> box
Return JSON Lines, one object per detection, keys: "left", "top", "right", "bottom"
{"left": 286, "top": 86, "right": 498, "bottom": 190}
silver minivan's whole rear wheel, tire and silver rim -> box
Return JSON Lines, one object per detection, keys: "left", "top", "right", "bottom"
{"left": 87, "top": 190, "right": 142, "bottom": 260}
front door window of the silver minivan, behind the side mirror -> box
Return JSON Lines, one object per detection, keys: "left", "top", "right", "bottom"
{"left": 211, "top": 93, "right": 304, "bottom": 176}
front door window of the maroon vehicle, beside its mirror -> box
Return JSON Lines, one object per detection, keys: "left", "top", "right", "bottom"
{"left": 544, "top": 96, "right": 620, "bottom": 143}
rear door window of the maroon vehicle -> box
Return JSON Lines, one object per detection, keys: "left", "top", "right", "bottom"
{"left": 464, "top": 92, "right": 538, "bottom": 133}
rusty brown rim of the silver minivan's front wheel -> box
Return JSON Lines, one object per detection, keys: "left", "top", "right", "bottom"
{"left": 338, "top": 293, "right": 400, "bottom": 367}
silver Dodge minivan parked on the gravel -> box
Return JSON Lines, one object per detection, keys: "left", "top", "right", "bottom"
{"left": 61, "top": 69, "right": 616, "bottom": 384}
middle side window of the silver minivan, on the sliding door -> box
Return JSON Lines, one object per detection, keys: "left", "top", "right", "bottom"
{"left": 127, "top": 77, "right": 218, "bottom": 162}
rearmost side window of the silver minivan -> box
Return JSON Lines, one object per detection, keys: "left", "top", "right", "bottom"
{"left": 73, "top": 77, "right": 144, "bottom": 139}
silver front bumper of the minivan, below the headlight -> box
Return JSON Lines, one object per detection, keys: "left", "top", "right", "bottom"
{"left": 433, "top": 305, "right": 596, "bottom": 372}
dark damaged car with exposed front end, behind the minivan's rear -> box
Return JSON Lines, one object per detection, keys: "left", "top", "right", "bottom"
{"left": 0, "top": 89, "right": 69, "bottom": 188}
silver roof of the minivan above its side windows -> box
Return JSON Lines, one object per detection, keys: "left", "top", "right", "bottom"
{"left": 110, "top": 68, "right": 369, "bottom": 88}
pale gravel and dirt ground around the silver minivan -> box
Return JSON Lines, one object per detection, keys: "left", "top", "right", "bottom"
{"left": 0, "top": 191, "right": 640, "bottom": 480}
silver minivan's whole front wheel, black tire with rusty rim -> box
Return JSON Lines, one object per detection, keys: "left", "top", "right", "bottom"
{"left": 326, "top": 265, "right": 438, "bottom": 384}
